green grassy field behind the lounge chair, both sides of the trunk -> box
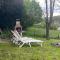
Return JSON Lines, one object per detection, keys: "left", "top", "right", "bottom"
{"left": 23, "top": 25, "right": 60, "bottom": 39}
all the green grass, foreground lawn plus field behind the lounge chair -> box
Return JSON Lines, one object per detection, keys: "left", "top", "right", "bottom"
{"left": 0, "top": 21, "right": 60, "bottom": 60}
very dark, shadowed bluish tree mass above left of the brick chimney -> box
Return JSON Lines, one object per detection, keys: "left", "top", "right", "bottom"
{"left": 0, "top": 0, "right": 23, "bottom": 28}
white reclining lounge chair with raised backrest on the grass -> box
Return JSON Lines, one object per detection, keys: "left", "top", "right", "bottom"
{"left": 11, "top": 31, "right": 43, "bottom": 47}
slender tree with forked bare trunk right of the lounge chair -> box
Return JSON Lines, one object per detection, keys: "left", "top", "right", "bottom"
{"left": 45, "top": 0, "right": 55, "bottom": 39}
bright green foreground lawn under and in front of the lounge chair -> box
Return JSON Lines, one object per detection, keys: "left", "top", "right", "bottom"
{"left": 0, "top": 39, "right": 60, "bottom": 60}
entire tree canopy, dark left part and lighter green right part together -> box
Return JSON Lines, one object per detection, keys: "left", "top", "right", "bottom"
{"left": 0, "top": 0, "right": 42, "bottom": 28}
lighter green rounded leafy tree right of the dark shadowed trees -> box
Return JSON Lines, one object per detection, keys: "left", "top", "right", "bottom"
{"left": 21, "top": 0, "right": 42, "bottom": 27}
